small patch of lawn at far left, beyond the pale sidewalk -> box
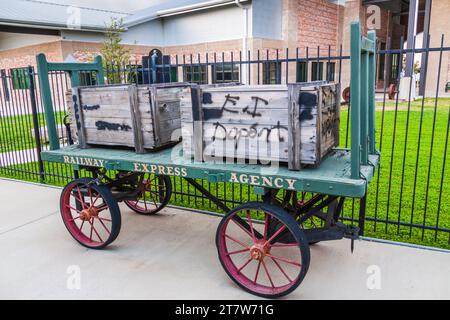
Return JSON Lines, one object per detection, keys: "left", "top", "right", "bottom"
{"left": 0, "top": 112, "right": 64, "bottom": 153}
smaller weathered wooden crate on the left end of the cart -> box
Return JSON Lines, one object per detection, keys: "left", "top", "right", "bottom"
{"left": 67, "top": 83, "right": 188, "bottom": 153}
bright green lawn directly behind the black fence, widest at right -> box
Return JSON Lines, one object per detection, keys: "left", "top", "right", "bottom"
{"left": 0, "top": 98, "right": 450, "bottom": 248}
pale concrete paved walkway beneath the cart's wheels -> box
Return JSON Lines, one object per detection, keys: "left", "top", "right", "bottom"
{"left": 0, "top": 179, "right": 450, "bottom": 300}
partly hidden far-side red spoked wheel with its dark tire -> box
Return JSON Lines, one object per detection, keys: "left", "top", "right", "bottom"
{"left": 124, "top": 174, "right": 172, "bottom": 215}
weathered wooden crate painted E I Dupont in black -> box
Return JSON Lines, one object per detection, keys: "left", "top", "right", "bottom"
{"left": 181, "top": 82, "right": 340, "bottom": 170}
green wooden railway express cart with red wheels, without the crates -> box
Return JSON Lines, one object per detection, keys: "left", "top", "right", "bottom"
{"left": 38, "top": 22, "right": 379, "bottom": 298}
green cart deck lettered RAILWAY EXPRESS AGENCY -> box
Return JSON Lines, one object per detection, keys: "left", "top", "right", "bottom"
{"left": 42, "top": 144, "right": 379, "bottom": 198}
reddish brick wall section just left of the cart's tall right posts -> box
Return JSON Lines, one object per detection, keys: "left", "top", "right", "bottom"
{"left": 298, "top": 0, "right": 341, "bottom": 54}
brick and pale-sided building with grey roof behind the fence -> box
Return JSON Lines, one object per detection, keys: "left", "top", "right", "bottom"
{"left": 0, "top": 0, "right": 450, "bottom": 95}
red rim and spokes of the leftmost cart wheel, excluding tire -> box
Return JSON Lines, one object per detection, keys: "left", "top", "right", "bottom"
{"left": 61, "top": 183, "right": 112, "bottom": 247}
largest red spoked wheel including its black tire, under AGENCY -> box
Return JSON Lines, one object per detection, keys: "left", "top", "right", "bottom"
{"left": 216, "top": 202, "right": 310, "bottom": 298}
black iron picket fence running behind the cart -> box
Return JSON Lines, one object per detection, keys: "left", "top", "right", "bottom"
{"left": 0, "top": 37, "right": 450, "bottom": 248}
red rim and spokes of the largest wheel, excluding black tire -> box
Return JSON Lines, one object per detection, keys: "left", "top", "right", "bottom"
{"left": 219, "top": 210, "right": 303, "bottom": 296}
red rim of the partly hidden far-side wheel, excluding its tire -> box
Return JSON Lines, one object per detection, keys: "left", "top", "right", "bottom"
{"left": 125, "top": 176, "right": 167, "bottom": 214}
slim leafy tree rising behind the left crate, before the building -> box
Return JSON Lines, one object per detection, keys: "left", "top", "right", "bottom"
{"left": 100, "top": 18, "right": 130, "bottom": 84}
